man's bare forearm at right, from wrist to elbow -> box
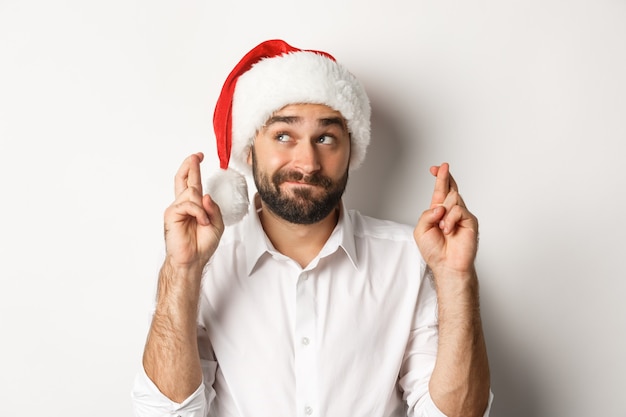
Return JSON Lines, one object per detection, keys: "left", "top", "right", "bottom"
{"left": 429, "top": 271, "right": 490, "bottom": 417}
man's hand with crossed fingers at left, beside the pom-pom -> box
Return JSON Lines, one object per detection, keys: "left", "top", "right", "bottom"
{"left": 164, "top": 153, "right": 224, "bottom": 271}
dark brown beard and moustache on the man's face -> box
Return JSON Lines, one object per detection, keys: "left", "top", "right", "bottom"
{"left": 252, "top": 147, "right": 348, "bottom": 224}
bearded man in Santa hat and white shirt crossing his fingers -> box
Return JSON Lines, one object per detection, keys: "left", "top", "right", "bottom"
{"left": 133, "top": 41, "right": 491, "bottom": 417}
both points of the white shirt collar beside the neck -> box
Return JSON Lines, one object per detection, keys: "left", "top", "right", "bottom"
{"left": 242, "top": 194, "right": 358, "bottom": 275}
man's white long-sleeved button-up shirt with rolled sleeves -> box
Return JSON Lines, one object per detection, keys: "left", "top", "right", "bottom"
{"left": 133, "top": 198, "right": 491, "bottom": 417}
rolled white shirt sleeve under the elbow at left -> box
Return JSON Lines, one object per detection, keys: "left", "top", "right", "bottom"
{"left": 131, "top": 367, "right": 206, "bottom": 417}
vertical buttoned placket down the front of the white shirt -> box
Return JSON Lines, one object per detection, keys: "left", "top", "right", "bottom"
{"left": 294, "top": 271, "right": 318, "bottom": 417}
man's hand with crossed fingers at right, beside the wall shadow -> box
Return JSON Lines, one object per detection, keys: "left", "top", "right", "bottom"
{"left": 413, "top": 163, "right": 478, "bottom": 278}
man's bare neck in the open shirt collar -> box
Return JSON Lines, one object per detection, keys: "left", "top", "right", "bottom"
{"left": 259, "top": 197, "right": 339, "bottom": 268}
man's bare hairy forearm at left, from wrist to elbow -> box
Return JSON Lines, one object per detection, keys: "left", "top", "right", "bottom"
{"left": 143, "top": 260, "right": 202, "bottom": 402}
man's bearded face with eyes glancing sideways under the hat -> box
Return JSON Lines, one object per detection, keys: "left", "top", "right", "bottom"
{"left": 249, "top": 104, "right": 350, "bottom": 224}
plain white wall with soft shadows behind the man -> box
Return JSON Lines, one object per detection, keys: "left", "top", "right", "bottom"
{"left": 0, "top": 0, "right": 626, "bottom": 417}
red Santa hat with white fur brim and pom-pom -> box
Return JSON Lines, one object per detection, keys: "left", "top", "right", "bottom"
{"left": 207, "top": 40, "right": 371, "bottom": 225}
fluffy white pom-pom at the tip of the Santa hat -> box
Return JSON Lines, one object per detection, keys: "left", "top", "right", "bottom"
{"left": 206, "top": 168, "right": 249, "bottom": 226}
